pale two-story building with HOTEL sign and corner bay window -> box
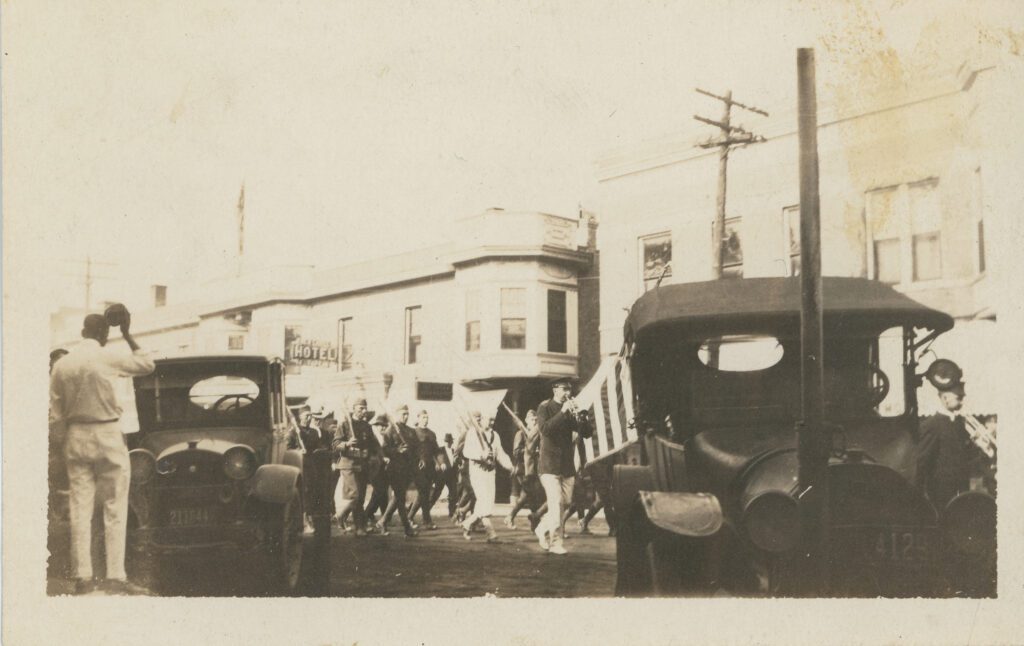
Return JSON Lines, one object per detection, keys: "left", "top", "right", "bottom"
{"left": 54, "top": 209, "right": 597, "bottom": 494}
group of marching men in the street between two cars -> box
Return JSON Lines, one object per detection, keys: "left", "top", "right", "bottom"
{"left": 295, "top": 380, "right": 603, "bottom": 554}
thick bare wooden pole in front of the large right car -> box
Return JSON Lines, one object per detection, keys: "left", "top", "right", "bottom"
{"left": 797, "top": 49, "right": 831, "bottom": 596}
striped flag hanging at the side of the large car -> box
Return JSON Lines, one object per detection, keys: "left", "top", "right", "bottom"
{"left": 575, "top": 355, "right": 637, "bottom": 468}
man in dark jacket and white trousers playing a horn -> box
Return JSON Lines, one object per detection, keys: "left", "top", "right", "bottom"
{"left": 535, "top": 378, "right": 594, "bottom": 554}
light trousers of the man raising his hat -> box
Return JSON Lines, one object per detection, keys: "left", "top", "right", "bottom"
{"left": 65, "top": 422, "right": 131, "bottom": 579}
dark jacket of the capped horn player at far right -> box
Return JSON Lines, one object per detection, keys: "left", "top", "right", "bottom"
{"left": 918, "top": 413, "right": 975, "bottom": 514}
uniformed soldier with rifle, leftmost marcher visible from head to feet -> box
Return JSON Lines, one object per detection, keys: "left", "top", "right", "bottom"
{"left": 331, "top": 397, "right": 381, "bottom": 536}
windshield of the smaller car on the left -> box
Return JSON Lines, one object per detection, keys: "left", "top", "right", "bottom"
{"left": 135, "top": 360, "right": 269, "bottom": 431}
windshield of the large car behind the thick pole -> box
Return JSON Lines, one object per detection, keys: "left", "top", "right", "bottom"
{"left": 634, "top": 328, "right": 906, "bottom": 428}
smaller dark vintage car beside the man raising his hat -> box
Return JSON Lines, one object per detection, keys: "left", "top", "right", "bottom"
{"left": 129, "top": 354, "right": 324, "bottom": 593}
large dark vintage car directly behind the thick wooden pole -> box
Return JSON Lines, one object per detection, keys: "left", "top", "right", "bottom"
{"left": 606, "top": 277, "right": 995, "bottom": 597}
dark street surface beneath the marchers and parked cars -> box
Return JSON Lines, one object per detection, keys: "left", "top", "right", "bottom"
{"left": 47, "top": 505, "right": 615, "bottom": 598}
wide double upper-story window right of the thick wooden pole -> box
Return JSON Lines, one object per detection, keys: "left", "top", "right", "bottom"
{"left": 865, "top": 178, "right": 942, "bottom": 285}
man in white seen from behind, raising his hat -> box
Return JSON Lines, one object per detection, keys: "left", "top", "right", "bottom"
{"left": 50, "top": 310, "right": 155, "bottom": 593}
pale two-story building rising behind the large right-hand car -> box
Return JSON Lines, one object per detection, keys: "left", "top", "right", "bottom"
{"left": 588, "top": 59, "right": 1015, "bottom": 413}
